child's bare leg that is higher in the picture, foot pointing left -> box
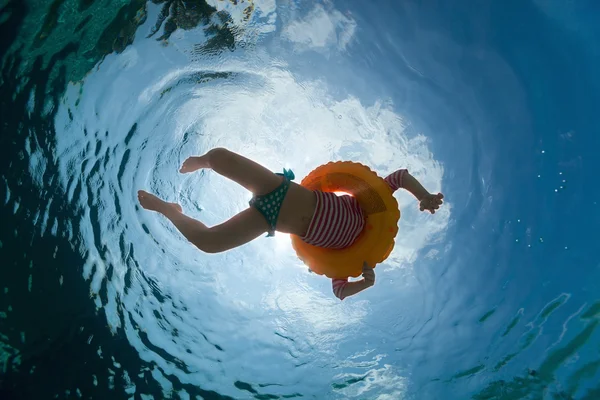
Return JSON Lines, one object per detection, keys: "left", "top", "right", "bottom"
{"left": 180, "top": 148, "right": 283, "bottom": 195}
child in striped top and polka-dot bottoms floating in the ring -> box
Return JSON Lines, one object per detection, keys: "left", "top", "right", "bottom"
{"left": 138, "top": 148, "right": 444, "bottom": 300}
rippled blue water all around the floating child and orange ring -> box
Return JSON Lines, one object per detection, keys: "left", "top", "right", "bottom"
{"left": 0, "top": 0, "right": 600, "bottom": 400}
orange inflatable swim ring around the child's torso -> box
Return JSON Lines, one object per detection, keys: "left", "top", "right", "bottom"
{"left": 291, "top": 161, "right": 400, "bottom": 278}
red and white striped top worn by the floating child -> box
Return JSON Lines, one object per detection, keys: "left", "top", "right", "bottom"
{"left": 301, "top": 169, "right": 407, "bottom": 249}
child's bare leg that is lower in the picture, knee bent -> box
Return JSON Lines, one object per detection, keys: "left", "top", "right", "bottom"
{"left": 138, "top": 190, "right": 269, "bottom": 253}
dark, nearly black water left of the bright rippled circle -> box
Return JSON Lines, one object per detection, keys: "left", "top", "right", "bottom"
{"left": 0, "top": 0, "right": 244, "bottom": 400}
